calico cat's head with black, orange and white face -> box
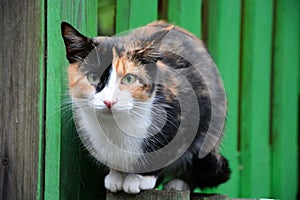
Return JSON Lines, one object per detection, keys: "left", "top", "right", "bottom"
{"left": 61, "top": 22, "right": 171, "bottom": 118}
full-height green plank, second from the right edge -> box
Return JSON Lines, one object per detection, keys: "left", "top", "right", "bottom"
{"left": 240, "top": 0, "right": 273, "bottom": 198}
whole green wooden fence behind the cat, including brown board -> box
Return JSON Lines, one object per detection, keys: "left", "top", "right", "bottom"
{"left": 0, "top": 0, "right": 300, "bottom": 200}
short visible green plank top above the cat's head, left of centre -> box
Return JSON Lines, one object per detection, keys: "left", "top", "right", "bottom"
{"left": 116, "top": 0, "right": 158, "bottom": 33}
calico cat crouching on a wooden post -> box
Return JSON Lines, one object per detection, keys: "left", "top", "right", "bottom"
{"left": 61, "top": 21, "right": 231, "bottom": 193}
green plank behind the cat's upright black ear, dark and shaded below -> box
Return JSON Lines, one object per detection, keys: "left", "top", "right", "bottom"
{"left": 60, "top": 0, "right": 101, "bottom": 200}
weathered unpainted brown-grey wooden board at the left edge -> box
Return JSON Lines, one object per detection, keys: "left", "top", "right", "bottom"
{"left": 0, "top": 0, "right": 43, "bottom": 200}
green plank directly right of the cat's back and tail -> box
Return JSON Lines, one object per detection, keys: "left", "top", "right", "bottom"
{"left": 207, "top": 0, "right": 241, "bottom": 197}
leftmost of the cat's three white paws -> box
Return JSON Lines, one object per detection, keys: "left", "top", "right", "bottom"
{"left": 104, "top": 169, "right": 124, "bottom": 192}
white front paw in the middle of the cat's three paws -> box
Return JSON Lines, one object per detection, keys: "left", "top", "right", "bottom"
{"left": 123, "top": 174, "right": 156, "bottom": 194}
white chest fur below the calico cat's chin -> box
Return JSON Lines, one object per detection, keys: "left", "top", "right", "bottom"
{"left": 75, "top": 107, "right": 150, "bottom": 171}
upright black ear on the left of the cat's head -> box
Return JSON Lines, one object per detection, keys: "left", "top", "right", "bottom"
{"left": 61, "top": 22, "right": 96, "bottom": 63}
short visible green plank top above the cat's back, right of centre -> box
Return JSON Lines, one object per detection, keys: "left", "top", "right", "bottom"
{"left": 168, "top": 0, "right": 202, "bottom": 38}
